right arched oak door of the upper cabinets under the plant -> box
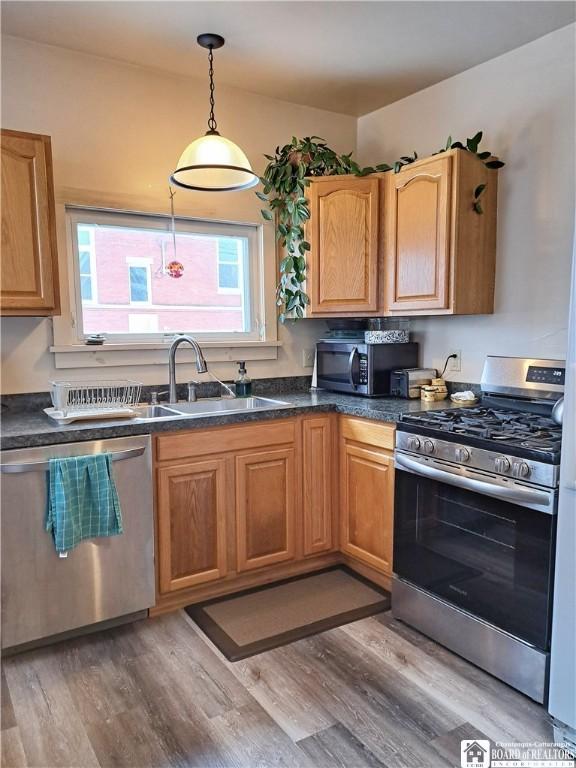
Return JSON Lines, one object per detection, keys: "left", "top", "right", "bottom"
{"left": 386, "top": 157, "right": 452, "bottom": 312}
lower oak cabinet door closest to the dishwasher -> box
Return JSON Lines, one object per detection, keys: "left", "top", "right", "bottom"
{"left": 158, "top": 459, "right": 228, "bottom": 592}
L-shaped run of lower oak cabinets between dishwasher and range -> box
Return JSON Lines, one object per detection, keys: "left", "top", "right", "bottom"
{"left": 155, "top": 414, "right": 394, "bottom": 612}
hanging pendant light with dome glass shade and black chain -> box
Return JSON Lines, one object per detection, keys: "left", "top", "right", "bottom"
{"left": 170, "top": 33, "right": 258, "bottom": 192}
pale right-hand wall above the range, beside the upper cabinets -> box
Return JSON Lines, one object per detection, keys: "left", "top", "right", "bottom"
{"left": 358, "top": 25, "right": 575, "bottom": 382}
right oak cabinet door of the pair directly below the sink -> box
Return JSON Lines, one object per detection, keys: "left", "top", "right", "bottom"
{"left": 236, "top": 448, "right": 297, "bottom": 571}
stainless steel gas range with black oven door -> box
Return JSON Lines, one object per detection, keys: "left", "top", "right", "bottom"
{"left": 392, "top": 357, "right": 565, "bottom": 702}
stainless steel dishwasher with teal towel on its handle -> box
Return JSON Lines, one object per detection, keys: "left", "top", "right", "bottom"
{"left": 0, "top": 436, "right": 155, "bottom": 649}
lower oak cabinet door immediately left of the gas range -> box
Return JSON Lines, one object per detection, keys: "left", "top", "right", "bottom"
{"left": 340, "top": 440, "right": 394, "bottom": 575}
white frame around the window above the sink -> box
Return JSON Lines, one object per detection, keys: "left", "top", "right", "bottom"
{"left": 67, "top": 206, "right": 264, "bottom": 344}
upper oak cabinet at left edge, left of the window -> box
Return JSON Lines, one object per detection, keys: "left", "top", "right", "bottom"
{"left": 0, "top": 130, "right": 60, "bottom": 316}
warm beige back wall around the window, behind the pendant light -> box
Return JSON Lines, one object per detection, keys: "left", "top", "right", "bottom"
{"left": 2, "top": 37, "right": 356, "bottom": 393}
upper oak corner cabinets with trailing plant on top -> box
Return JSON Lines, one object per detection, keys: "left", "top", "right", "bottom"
{"left": 306, "top": 149, "right": 498, "bottom": 317}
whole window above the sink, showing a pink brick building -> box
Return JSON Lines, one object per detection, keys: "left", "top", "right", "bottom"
{"left": 68, "top": 208, "right": 263, "bottom": 342}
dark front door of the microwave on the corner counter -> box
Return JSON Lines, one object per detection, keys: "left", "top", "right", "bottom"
{"left": 316, "top": 341, "right": 369, "bottom": 395}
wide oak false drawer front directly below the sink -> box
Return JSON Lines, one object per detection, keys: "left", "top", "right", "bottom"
{"left": 156, "top": 419, "right": 296, "bottom": 461}
